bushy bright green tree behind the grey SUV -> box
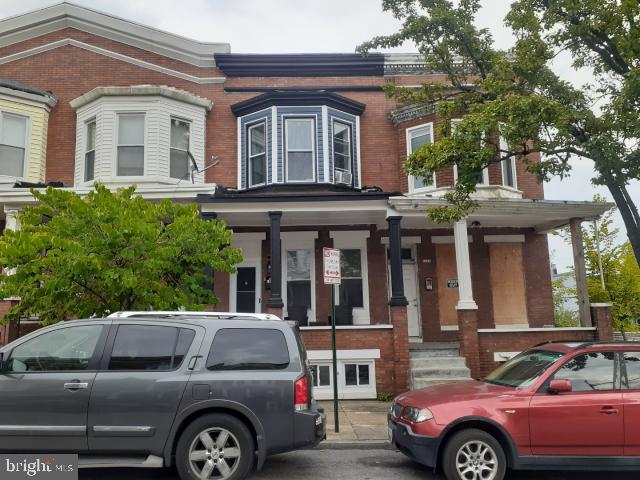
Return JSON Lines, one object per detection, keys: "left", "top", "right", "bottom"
{"left": 0, "top": 185, "right": 241, "bottom": 324}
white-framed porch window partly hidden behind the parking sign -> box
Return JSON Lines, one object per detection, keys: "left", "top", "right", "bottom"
{"left": 330, "top": 230, "right": 371, "bottom": 325}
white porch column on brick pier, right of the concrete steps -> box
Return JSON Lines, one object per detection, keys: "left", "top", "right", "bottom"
{"left": 453, "top": 219, "right": 480, "bottom": 378}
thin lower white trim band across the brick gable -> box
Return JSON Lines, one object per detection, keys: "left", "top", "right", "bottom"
{"left": 0, "top": 39, "right": 226, "bottom": 84}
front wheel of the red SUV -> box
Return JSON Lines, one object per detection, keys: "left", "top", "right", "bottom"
{"left": 442, "top": 429, "right": 507, "bottom": 480}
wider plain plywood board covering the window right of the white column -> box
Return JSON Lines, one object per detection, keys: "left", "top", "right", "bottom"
{"left": 489, "top": 243, "right": 528, "bottom": 326}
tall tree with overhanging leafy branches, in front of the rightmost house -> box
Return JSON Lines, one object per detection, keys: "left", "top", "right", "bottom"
{"left": 358, "top": 0, "right": 640, "bottom": 263}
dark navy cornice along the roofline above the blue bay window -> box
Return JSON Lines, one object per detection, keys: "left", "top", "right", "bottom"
{"left": 215, "top": 53, "right": 384, "bottom": 77}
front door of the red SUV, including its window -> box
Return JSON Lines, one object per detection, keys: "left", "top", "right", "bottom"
{"left": 529, "top": 352, "right": 624, "bottom": 456}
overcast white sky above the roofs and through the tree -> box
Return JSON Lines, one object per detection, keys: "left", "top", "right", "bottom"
{"left": 0, "top": 0, "right": 640, "bottom": 270}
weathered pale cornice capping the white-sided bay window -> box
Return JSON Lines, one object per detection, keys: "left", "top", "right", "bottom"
{"left": 69, "top": 85, "right": 213, "bottom": 111}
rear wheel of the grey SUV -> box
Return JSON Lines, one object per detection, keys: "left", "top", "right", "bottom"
{"left": 176, "top": 413, "right": 255, "bottom": 480}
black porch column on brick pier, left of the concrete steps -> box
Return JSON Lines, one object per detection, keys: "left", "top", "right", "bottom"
{"left": 387, "top": 217, "right": 410, "bottom": 394}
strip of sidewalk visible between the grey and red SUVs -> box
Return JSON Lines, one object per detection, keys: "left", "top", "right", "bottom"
{"left": 319, "top": 400, "right": 391, "bottom": 448}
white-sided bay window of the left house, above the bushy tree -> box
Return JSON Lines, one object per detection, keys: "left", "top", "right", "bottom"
{"left": 75, "top": 96, "right": 206, "bottom": 186}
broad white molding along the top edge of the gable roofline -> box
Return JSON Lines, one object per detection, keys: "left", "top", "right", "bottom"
{"left": 0, "top": 2, "right": 231, "bottom": 67}
